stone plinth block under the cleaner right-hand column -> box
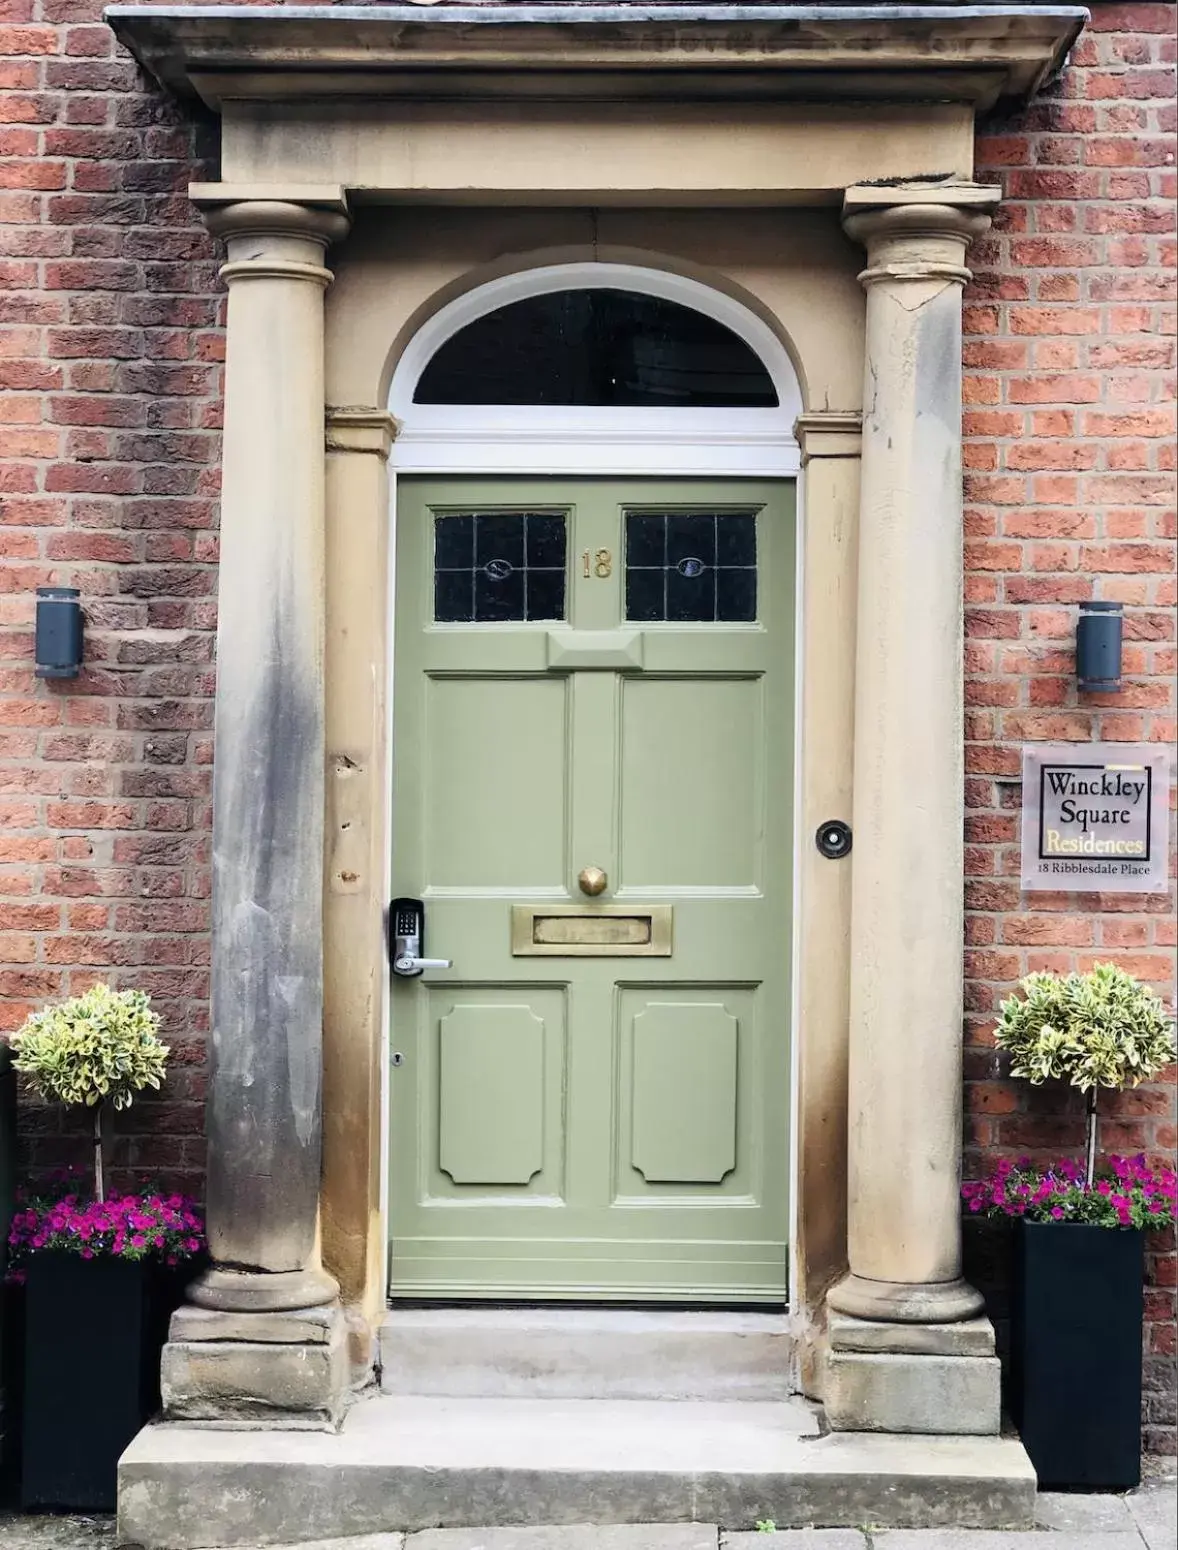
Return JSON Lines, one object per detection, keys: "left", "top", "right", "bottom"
{"left": 823, "top": 1313, "right": 1001, "bottom": 1437}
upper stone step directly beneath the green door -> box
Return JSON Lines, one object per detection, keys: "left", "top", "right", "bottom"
{"left": 380, "top": 1307, "right": 797, "bottom": 1400}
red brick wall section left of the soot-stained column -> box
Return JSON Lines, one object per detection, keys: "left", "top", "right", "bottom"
{"left": 0, "top": 0, "right": 222, "bottom": 1187}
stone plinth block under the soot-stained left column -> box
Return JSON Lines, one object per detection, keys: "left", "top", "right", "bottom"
{"left": 160, "top": 1304, "right": 353, "bottom": 1432}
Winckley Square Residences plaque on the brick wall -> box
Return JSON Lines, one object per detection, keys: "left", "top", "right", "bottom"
{"left": 1021, "top": 742, "right": 1170, "bottom": 893}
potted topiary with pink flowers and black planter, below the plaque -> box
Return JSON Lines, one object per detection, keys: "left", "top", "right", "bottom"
{"left": 963, "top": 964, "right": 1175, "bottom": 1490}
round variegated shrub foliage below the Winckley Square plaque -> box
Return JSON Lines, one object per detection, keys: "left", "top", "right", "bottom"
{"left": 994, "top": 964, "right": 1175, "bottom": 1093}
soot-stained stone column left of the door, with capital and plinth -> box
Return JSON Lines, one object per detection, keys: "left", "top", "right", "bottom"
{"left": 163, "top": 184, "right": 349, "bottom": 1426}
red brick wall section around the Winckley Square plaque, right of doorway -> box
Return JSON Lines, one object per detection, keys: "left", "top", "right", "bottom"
{"left": 964, "top": 5, "right": 1178, "bottom": 1452}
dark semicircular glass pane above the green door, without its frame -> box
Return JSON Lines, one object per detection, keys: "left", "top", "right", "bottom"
{"left": 414, "top": 290, "right": 778, "bottom": 409}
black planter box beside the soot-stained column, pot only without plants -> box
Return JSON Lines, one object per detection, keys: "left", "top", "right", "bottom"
{"left": 20, "top": 1254, "right": 184, "bottom": 1511}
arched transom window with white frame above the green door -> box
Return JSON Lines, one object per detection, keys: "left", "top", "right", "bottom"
{"left": 389, "top": 264, "right": 801, "bottom": 477}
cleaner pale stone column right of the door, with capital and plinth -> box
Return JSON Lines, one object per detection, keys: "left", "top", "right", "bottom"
{"left": 828, "top": 184, "right": 1000, "bottom": 1431}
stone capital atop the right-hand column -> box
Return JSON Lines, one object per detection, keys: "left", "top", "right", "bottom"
{"left": 843, "top": 183, "right": 1001, "bottom": 285}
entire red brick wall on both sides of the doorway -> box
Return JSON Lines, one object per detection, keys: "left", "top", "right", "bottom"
{"left": 0, "top": 0, "right": 1175, "bottom": 1452}
